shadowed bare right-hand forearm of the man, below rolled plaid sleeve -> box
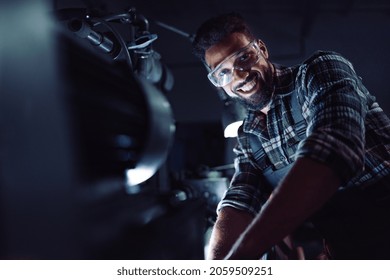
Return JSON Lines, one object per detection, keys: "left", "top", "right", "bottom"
{"left": 227, "top": 158, "right": 340, "bottom": 259}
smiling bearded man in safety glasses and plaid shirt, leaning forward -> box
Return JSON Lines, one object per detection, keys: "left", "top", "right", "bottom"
{"left": 193, "top": 13, "right": 390, "bottom": 259}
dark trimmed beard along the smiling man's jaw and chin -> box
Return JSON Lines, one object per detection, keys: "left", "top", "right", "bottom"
{"left": 233, "top": 62, "right": 275, "bottom": 110}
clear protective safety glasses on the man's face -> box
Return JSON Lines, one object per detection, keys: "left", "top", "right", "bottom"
{"left": 207, "top": 40, "right": 260, "bottom": 87}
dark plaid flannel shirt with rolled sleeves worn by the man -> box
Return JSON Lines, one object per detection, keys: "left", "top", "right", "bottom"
{"left": 218, "top": 51, "right": 390, "bottom": 214}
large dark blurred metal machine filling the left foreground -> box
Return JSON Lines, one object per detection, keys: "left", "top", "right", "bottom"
{"left": 0, "top": 1, "right": 206, "bottom": 259}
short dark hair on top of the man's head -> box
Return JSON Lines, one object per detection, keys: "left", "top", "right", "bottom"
{"left": 192, "top": 12, "right": 255, "bottom": 63}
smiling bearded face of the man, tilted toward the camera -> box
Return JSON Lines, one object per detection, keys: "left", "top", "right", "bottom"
{"left": 205, "top": 33, "right": 274, "bottom": 110}
